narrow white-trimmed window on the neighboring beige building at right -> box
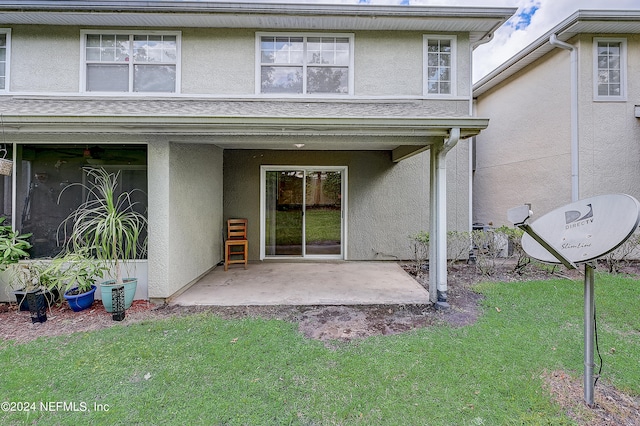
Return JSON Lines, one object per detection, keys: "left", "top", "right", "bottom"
{"left": 593, "top": 38, "right": 627, "bottom": 101}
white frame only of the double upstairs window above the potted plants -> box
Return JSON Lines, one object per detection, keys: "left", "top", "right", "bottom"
{"left": 80, "top": 29, "right": 182, "bottom": 96}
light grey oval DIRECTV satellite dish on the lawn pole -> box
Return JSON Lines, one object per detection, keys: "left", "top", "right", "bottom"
{"left": 522, "top": 194, "right": 640, "bottom": 263}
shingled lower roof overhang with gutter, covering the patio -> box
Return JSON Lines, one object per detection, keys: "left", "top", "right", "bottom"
{"left": 0, "top": 97, "right": 488, "bottom": 153}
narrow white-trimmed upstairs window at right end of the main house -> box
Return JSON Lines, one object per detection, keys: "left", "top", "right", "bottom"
{"left": 424, "top": 35, "right": 457, "bottom": 96}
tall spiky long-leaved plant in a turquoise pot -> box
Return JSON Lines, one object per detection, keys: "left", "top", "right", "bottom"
{"left": 58, "top": 168, "right": 147, "bottom": 312}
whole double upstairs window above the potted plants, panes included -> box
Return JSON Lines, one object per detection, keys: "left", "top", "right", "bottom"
{"left": 82, "top": 31, "right": 180, "bottom": 93}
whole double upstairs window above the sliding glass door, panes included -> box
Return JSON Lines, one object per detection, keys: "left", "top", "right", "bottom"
{"left": 256, "top": 34, "right": 353, "bottom": 95}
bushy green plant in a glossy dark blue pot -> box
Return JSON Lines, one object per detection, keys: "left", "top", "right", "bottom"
{"left": 43, "top": 247, "right": 107, "bottom": 312}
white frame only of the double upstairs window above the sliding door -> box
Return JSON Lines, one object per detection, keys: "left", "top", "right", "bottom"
{"left": 255, "top": 32, "right": 355, "bottom": 98}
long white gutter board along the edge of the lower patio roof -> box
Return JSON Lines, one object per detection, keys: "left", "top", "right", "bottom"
{"left": 3, "top": 115, "right": 489, "bottom": 137}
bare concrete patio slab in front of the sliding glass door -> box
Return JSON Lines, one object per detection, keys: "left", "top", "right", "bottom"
{"left": 170, "top": 262, "right": 429, "bottom": 306}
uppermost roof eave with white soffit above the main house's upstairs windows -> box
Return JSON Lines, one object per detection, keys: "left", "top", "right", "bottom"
{"left": 0, "top": 0, "right": 516, "bottom": 42}
